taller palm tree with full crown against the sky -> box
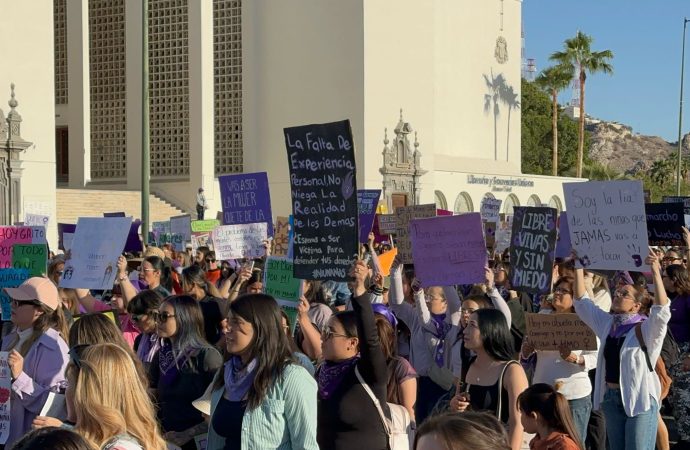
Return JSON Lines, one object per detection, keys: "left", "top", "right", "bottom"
{"left": 549, "top": 31, "right": 613, "bottom": 177}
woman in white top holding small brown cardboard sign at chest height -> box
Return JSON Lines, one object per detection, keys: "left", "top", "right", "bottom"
{"left": 520, "top": 277, "right": 598, "bottom": 442}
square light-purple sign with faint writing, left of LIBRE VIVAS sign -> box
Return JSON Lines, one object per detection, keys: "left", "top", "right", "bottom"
{"left": 408, "top": 213, "right": 488, "bottom": 287}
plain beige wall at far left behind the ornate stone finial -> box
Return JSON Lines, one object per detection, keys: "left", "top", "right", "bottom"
{"left": 0, "top": 0, "right": 57, "bottom": 249}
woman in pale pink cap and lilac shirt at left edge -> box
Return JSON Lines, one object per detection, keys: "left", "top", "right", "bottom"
{"left": 2, "top": 277, "right": 68, "bottom": 447}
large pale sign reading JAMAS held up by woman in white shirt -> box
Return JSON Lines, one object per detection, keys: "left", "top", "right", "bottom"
{"left": 563, "top": 181, "right": 649, "bottom": 271}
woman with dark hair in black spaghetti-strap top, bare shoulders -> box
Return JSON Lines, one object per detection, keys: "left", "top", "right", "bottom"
{"left": 450, "top": 309, "right": 527, "bottom": 450}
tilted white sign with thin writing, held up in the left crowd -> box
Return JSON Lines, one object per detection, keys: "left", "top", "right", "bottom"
{"left": 60, "top": 217, "right": 132, "bottom": 290}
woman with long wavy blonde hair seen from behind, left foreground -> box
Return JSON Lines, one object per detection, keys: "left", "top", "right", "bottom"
{"left": 65, "top": 344, "right": 166, "bottom": 450}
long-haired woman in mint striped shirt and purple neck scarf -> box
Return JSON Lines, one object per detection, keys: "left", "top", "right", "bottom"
{"left": 207, "top": 294, "right": 318, "bottom": 450}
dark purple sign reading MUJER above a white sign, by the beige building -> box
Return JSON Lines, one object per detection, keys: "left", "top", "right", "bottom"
{"left": 218, "top": 172, "right": 273, "bottom": 236}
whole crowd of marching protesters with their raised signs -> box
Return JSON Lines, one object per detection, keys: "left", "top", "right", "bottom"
{"left": 0, "top": 117, "right": 690, "bottom": 450}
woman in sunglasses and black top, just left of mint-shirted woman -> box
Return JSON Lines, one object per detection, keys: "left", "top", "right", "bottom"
{"left": 150, "top": 295, "right": 223, "bottom": 450}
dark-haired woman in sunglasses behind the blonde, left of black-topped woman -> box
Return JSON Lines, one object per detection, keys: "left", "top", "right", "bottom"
{"left": 127, "top": 289, "right": 163, "bottom": 371}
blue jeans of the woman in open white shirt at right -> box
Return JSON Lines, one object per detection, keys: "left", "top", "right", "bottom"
{"left": 601, "top": 388, "right": 659, "bottom": 450}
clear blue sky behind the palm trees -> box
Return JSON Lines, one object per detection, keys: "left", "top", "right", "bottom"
{"left": 522, "top": 0, "right": 690, "bottom": 142}
